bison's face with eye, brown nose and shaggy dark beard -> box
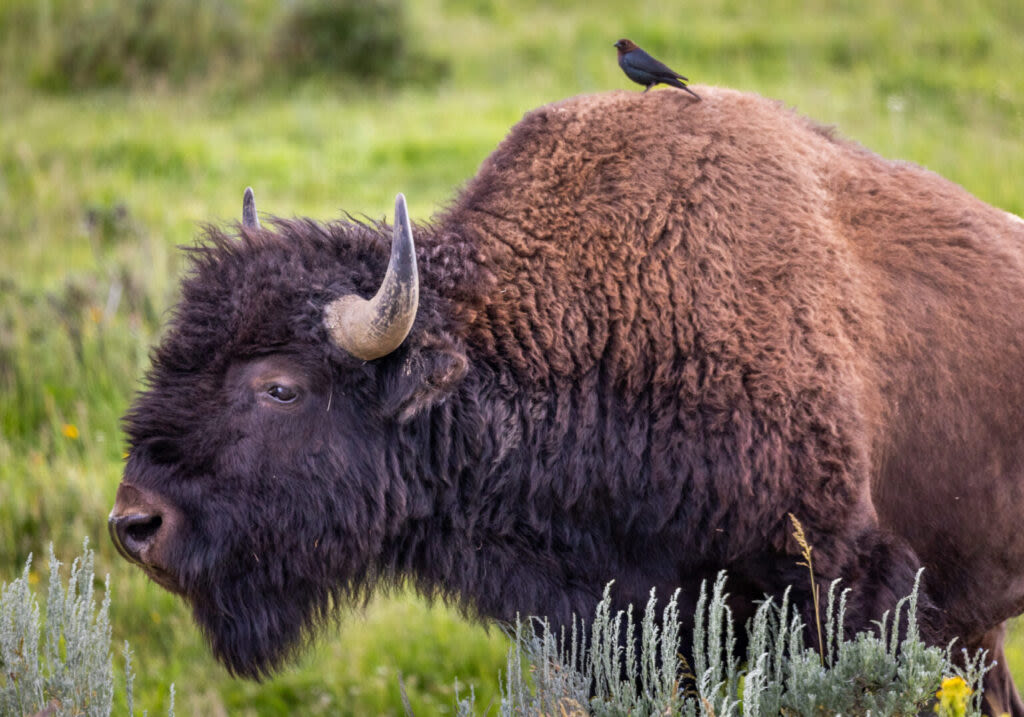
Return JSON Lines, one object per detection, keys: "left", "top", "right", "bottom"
{"left": 110, "top": 353, "right": 387, "bottom": 677}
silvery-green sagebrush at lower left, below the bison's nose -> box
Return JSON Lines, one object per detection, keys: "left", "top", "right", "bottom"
{"left": 0, "top": 540, "right": 174, "bottom": 717}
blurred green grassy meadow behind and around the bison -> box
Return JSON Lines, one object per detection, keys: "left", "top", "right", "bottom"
{"left": 0, "top": 0, "right": 1024, "bottom": 715}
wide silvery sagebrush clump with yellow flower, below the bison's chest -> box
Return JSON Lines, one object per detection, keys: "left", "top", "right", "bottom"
{"left": 457, "top": 573, "right": 988, "bottom": 717}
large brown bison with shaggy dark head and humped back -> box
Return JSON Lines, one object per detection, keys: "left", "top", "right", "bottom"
{"left": 110, "top": 87, "right": 1024, "bottom": 717}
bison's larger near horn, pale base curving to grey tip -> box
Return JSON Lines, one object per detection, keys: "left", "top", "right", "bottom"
{"left": 324, "top": 195, "right": 420, "bottom": 361}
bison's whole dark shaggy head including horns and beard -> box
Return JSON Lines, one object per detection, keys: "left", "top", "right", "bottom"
{"left": 110, "top": 191, "right": 458, "bottom": 677}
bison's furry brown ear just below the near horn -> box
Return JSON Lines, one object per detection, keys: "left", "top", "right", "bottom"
{"left": 384, "top": 334, "right": 469, "bottom": 423}
